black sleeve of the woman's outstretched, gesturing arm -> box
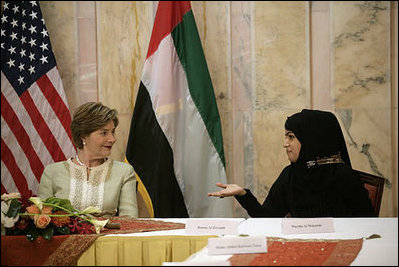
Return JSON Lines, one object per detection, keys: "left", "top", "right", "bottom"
{"left": 235, "top": 169, "right": 288, "bottom": 217}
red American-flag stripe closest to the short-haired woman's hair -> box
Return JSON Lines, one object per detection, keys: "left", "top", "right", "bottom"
{"left": 36, "top": 75, "right": 72, "bottom": 141}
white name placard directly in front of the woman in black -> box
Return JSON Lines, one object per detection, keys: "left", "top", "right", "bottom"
{"left": 282, "top": 218, "right": 335, "bottom": 234}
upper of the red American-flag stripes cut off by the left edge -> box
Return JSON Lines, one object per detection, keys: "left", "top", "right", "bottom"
{"left": 1, "top": 93, "right": 44, "bottom": 181}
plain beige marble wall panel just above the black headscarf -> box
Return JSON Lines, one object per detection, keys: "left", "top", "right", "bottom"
{"left": 253, "top": 1, "right": 309, "bottom": 110}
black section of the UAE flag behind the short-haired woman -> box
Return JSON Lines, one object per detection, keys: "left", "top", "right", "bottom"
{"left": 126, "top": 82, "right": 188, "bottom": 218}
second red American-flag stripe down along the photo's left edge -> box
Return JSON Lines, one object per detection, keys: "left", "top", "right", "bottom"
{"left": 1, "top": 139, "right": 29, "bottom": 195}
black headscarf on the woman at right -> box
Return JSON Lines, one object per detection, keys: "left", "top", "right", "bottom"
{"left": 285, "top": 109, "right": 352, "bottom": 166}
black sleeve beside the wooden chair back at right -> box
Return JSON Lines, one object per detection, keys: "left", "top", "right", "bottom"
{"left": 341, "top": 168, "right": 377, "bottom": 217}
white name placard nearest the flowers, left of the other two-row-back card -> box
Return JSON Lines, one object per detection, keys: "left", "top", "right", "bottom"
{"left": 185, "top": 219, "right": 238, "bottom": 235}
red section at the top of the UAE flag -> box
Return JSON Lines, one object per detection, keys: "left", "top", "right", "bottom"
{"left": 146, "top": 1, "right": 191, "bottom": 59}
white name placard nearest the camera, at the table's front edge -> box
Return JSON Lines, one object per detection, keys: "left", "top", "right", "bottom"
{"left": 208, "top": 236, "right": 267, "bottom": 255}
